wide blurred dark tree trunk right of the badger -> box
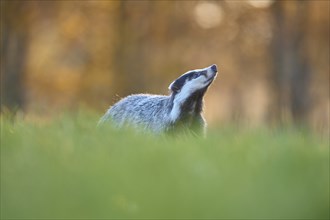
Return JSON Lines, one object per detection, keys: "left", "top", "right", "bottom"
{"left": 271, "top": 1, "right": 310, "bottom": 124}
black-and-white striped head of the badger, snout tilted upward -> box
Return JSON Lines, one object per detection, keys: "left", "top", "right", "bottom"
{"left": 168, "top": 64, "right": 218, "bottom": 95}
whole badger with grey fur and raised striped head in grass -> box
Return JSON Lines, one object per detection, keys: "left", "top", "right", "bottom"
{"left": 99, "top": 64, "right": 218, "bottom": 135}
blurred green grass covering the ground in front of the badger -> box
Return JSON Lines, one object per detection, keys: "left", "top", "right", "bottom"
{"left": 1, "top": 113, "right": 329, "bottom": 219}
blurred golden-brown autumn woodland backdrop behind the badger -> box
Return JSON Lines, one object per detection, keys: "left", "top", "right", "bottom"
{"left": 1, "top": 0, "right": 330, "bottom": 133}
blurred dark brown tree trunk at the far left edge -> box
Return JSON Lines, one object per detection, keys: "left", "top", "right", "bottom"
{"left": 0, "top": 1, "right": 27, "bottom": 112}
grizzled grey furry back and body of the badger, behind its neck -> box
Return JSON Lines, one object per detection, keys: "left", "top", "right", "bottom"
{"left": 101, "top": 94, "right": 171, "bottom": 133}
